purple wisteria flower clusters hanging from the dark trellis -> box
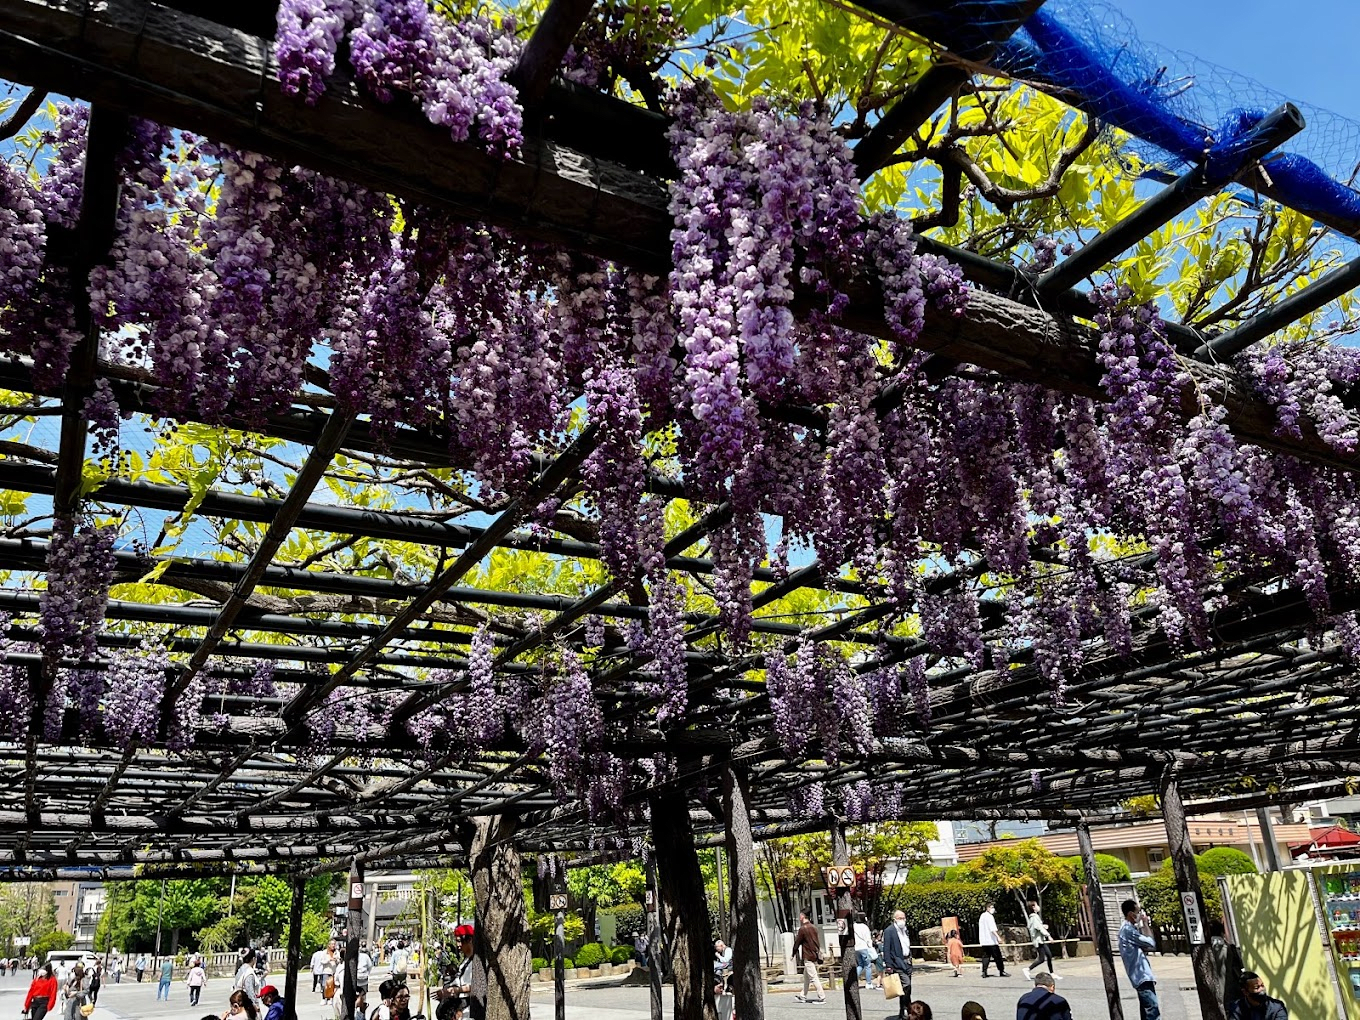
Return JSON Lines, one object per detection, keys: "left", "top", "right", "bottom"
{"left": 0, "top": 0, "right": 1360, "bottom": 864}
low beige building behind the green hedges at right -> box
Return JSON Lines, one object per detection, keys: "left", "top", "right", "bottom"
{"left": 956, "top": 812, "right": 1310, "bottom": 876}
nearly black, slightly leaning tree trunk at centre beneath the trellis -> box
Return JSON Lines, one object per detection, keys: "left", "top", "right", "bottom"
{"left": 651, "top": 790, "right": 718, "bottom": 1020}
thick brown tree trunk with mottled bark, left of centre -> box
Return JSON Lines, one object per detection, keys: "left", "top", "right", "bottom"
{"left": 469, "top": 815, "right": 533, "bottom": 1020}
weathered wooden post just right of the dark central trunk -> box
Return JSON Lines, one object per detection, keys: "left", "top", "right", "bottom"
{"left": 722, "top": 766, "right": 764, "bottom": 1020}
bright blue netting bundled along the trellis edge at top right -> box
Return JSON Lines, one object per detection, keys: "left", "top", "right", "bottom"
{"left": 940, "top": 0, "right": 1360, "bottom": 233}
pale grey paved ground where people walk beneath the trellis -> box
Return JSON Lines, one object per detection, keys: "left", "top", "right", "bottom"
{"left": 0, "top": 956, "right": 1200, "bottom": 1020}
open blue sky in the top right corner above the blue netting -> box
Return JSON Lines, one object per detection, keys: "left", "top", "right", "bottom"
{"left": 1112, "top": 0, "right": 1360, "bottom": 122}
